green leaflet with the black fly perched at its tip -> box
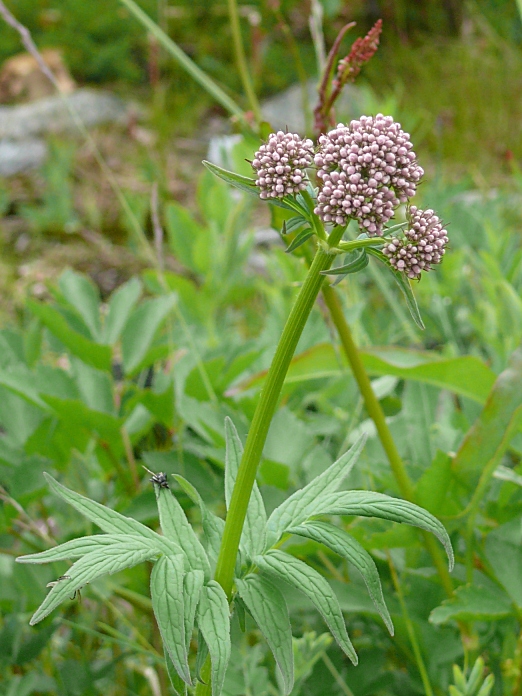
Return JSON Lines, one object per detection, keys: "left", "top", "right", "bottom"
{"left": 154, "top": 484, "right": 210, "bottom": 578}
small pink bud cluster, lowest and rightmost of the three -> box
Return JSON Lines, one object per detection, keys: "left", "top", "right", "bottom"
{"left": 382, "top": 205, "right": 448, "bottom": 278}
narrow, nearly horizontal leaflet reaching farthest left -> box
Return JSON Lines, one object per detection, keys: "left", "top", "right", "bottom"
{"left": 16, "top": 534, "right": 160, "bottom": 563}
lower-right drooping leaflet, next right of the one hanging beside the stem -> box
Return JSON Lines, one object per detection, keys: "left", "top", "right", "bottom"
{"left": 254, "top": 549, "right": 358, "bottom": 665}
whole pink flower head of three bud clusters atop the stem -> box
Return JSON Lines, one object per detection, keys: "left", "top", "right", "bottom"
{"left": 252, "top": 114, "right": 448, "bottom": 278}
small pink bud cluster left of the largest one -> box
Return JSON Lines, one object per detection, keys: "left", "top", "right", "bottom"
{"left": 252, "top": 131, "right": 314, "bottom": 198}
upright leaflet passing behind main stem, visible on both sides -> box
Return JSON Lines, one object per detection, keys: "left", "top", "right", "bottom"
{"left": 225, "top": 417, "right": 266, "bottom": 557}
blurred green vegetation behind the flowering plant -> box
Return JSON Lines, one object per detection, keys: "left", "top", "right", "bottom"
{"left": 0, "top": 0, "right": 522, "bottom": 696}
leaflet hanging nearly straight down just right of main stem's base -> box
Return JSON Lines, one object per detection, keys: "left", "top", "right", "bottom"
{"left": 236, "top": 575, "right": 294, "bottom": 694}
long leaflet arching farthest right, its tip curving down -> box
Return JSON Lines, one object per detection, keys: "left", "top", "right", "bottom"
{"left": 308, "top": 491, "right": 454, "bottom": 570}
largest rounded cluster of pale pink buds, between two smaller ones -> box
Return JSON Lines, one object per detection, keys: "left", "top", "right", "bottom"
{"left": 315, "top": 114, "right": 424, "bottom": 237}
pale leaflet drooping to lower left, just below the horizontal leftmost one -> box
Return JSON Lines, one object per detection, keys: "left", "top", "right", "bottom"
{"left": 29, "top": 544, "right": 157, "bottom": 626}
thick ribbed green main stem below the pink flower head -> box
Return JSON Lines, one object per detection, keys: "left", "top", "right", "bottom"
{"left": 215, "top": 227, "right": 344, "bottom": 597}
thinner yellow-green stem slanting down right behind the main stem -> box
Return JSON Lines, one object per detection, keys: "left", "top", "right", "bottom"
{"left": 323, "top": 285, "right": 453, "bottom": 597}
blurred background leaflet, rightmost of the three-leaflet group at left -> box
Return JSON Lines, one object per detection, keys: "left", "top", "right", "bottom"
{"left": 121, "top": 293, "right": 177, "bottom": 374}
